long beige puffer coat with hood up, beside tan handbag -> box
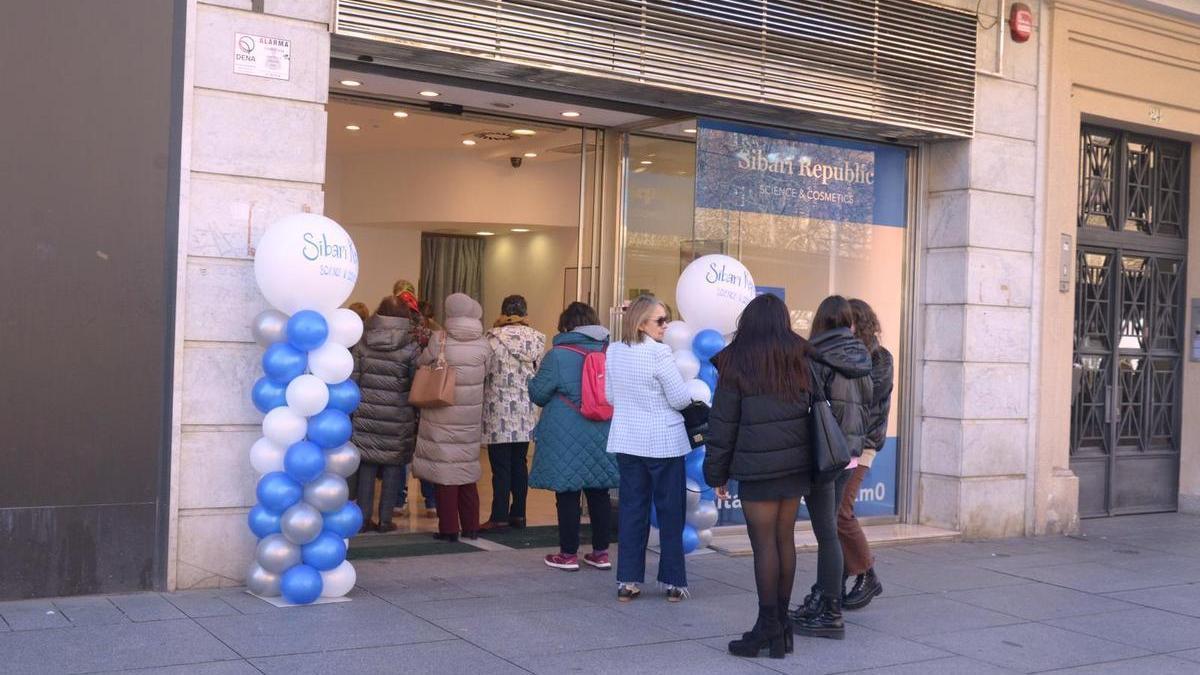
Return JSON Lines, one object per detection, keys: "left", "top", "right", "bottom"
{"left": 413, "top": 293, "right": 492, "bottom": 485}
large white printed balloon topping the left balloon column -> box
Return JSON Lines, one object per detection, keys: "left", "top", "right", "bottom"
{"left": 254, "top": 214, "right": 359, "bottom": 315}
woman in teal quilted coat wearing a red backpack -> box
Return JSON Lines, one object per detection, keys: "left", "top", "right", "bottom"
{"left": 529, "top": 303, "right": 619, "bottom": 572}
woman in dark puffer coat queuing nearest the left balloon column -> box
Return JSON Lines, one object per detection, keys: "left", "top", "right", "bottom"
{"left": 353, "top": 295, "right": 421, "bottom": 532}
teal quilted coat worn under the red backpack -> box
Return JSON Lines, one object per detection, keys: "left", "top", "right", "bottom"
{"left": 529, "top": 325, "right": 619, "bottom": 492}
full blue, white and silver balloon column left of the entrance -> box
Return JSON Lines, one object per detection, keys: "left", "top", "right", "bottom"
{"left": 246, "top": 214, "right": 362, "bottom": 604}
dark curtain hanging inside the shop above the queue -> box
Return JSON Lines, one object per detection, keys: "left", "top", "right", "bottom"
{"left": 419, "top": 234, "right": 485, "bottom": 324}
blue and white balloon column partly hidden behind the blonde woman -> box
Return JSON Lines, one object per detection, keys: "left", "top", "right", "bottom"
{"left": 664, "top": 256, "right": 755, "bottom": 554}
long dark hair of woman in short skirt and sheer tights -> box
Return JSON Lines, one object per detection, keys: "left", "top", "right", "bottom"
{"left": 714, "top": 293, "right": 812, "bottom": 401}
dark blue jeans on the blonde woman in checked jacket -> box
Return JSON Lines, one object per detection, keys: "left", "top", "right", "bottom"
{"left": 617, "top": 454, "right": 688, "bottom": 589}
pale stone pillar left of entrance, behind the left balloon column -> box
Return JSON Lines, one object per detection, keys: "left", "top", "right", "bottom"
{"left": 168, "top": 0, "right": 330, "bottom": 589}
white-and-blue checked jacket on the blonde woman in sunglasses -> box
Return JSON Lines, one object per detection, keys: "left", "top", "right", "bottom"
{"left": 605, "top": 338, "right": 691, "bottom": 459}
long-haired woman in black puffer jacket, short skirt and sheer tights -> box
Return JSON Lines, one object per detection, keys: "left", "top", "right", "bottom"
{"left": 704, "top": 294, "right": 820, "bottom": 658}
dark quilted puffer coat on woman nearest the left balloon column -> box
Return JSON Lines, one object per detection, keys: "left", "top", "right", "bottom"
{"left": 353, "top": 315, "right": 421, "bottom": 465}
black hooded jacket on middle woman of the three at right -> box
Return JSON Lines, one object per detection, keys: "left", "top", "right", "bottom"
{"left": 810, "top": 328, "right": 872, "bottom": 458}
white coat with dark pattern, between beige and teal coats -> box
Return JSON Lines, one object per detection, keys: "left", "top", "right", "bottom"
{"left": 484, "top": 324, "right": 546, "bottom": 443}
